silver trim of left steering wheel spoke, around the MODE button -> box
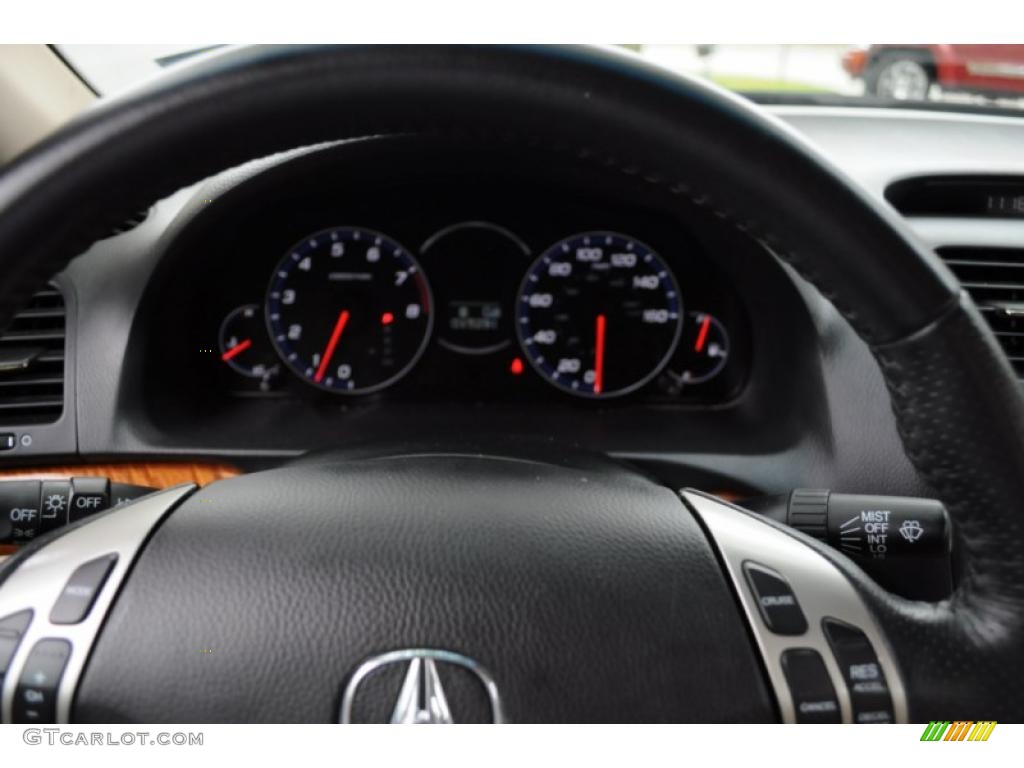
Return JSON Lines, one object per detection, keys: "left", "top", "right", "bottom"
{"left": 0, "top": 483, "right": 196, "bottom": 723}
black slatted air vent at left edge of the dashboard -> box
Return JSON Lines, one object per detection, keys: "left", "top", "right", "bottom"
{"left": 0, "top": 286, "right": 66, "bottom": 426}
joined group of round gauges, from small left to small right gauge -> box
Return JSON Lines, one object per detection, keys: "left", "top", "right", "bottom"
{"left": 209, "top": 221, "right": 737, "bottom": 400}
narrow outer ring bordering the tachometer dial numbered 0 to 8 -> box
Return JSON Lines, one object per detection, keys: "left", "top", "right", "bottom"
{"left": 263, "top": 224, "right": 434, "bottom": 397}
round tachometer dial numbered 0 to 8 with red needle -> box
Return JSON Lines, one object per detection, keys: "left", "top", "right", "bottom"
{"left": 266, "top": 227, "right": 431, "bottom": 394}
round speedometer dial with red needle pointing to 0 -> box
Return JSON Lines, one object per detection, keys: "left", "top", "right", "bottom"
{"left": 515, "top": 231, "right": 683, "bottom": 397}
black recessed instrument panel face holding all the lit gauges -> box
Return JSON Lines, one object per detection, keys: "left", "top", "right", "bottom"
{"left": 150, "top": 141, "right": 751, "bottom": 408}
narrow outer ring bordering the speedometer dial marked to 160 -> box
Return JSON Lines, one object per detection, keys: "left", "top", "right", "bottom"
{"left": 513, "top": 229, "right": 686, "bottom": 400}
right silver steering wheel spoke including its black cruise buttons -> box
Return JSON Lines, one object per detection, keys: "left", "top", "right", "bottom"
{"left": 682, "top": 489, "right": 907, "bottom": 723}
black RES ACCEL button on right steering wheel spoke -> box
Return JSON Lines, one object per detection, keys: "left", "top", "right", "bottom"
{"left": 821, "top": 618, "right": 895, "bottom": 723}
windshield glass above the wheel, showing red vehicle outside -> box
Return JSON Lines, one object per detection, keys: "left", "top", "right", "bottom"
{"left": 57, "top": 43, "right": 1024, "bottom": 110}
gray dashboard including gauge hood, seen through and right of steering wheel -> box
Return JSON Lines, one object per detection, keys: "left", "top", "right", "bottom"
{"left": 5, "top": 106, "right": 1024, "bottom": 496}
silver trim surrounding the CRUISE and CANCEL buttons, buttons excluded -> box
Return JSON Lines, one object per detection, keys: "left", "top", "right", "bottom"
{"left": 682, "top": 489, "right": 907, "bottom": 723}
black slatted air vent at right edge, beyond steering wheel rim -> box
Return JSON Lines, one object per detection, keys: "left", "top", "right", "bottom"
{"left": 938, "top": 247, "right": 1024, "bottom": 379}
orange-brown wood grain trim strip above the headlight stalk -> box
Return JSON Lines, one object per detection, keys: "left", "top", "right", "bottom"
{"left": 0, "top": 462, "right": 242, "bottom": 488}
